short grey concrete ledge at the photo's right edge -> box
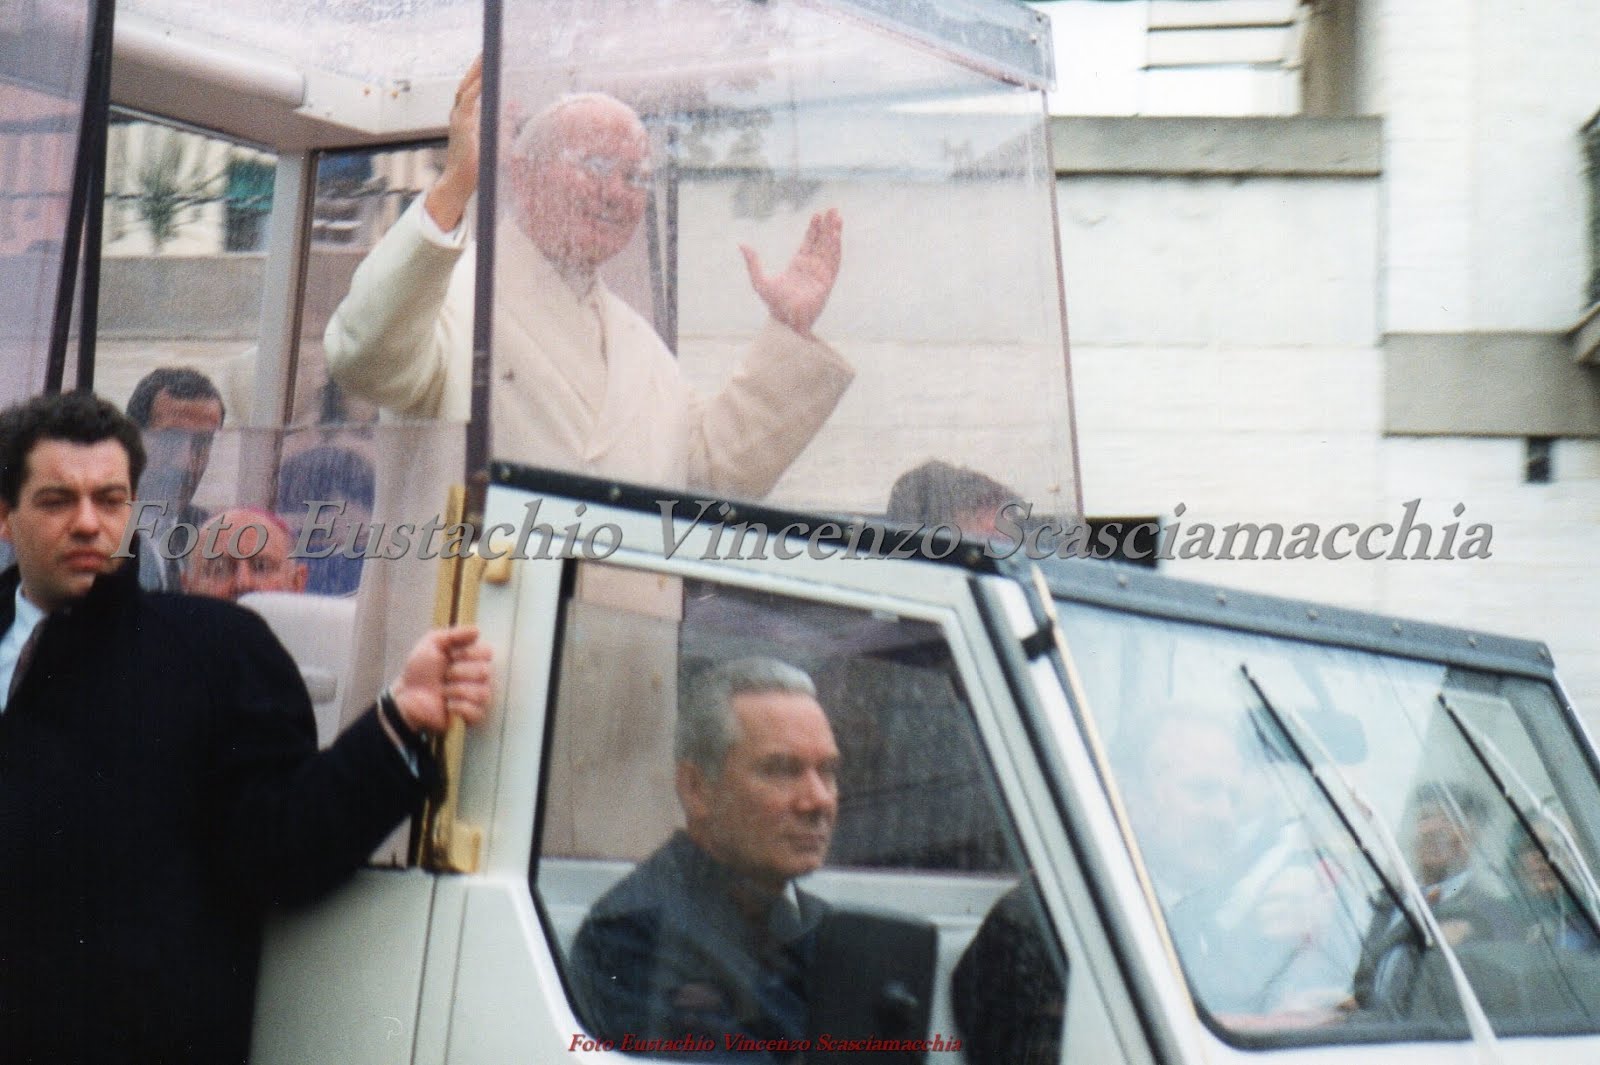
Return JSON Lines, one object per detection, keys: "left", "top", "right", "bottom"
{"left": 1384, "top": 333, "right": 1600, "bottom": 437}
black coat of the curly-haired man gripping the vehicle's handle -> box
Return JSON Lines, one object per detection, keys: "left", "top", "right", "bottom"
{"left": 0, "top": 564, "right": 430, "bottom": 1065}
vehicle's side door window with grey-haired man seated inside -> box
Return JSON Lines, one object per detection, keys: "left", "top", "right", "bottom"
{"left": 530, "top": 563, "right": 1066, "bottom": 1063}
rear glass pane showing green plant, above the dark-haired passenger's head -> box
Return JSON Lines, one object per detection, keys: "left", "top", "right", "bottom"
{"left": 94, "top": 114, "right": 278, "bottom": 428}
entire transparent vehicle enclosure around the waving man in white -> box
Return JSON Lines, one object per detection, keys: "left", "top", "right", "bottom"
{"left": 87, "top": 0, "right": 1078, "bottom": 741}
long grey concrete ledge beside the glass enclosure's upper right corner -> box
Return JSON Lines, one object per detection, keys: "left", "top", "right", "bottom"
{"left": 1050, "top": 115, "right": 1382, "bottom": 178}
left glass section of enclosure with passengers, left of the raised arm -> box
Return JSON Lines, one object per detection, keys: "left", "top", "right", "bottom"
{"left": 96, "top": 112, "right": 462, "bottom": 742}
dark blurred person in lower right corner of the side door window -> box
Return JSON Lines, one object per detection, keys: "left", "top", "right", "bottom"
{"left": 950, "top": 876, "right": 1066, "bottom": 1065}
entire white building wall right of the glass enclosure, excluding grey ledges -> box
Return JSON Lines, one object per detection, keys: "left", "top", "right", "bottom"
{"left": 1051, "top": 0, "right": 1600, "bottom": 731}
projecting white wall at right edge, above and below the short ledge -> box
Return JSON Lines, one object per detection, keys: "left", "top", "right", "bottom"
{"left": 1374, "top": 0, "right": 1600, "bottom": 723}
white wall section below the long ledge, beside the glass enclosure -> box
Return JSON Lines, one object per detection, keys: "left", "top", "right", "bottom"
{"left": 1059, "top": 176, "right": 1382, "bottom": 606}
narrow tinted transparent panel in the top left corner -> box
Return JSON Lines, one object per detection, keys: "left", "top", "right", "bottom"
{"left": 0, "top": 0, "right": 91, "bottom": 406}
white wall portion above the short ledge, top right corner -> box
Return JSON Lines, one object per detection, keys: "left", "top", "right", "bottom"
{"left": 1378, "top": 0, "right": 1600, "bottom": 333}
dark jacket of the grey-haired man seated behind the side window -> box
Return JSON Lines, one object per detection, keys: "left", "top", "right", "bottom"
{"left": 566, "top": 832, "right": 827, "bottom": 1062}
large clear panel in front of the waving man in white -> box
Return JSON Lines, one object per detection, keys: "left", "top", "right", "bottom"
{"left": 470, "top": 0, "right": 1078, "bottom": 518}
